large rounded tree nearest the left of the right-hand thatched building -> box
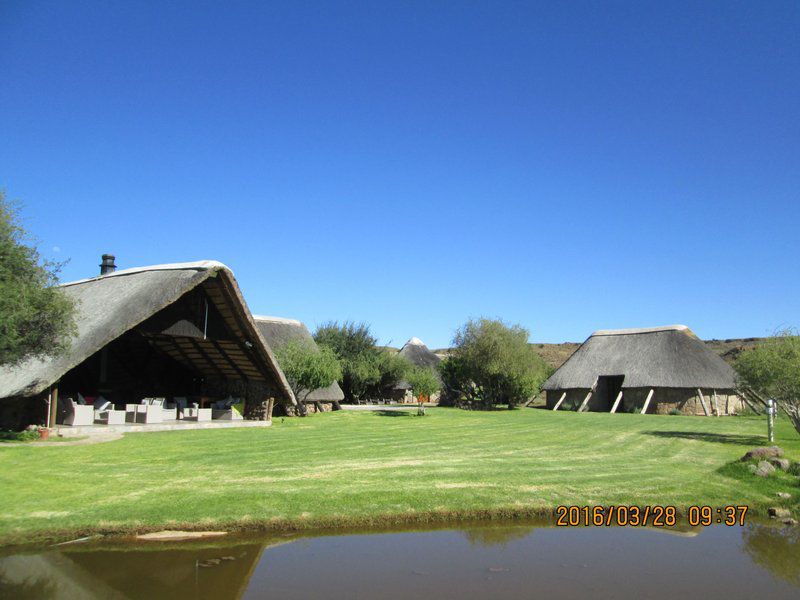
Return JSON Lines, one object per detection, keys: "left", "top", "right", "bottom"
{"left": 440, "top": 318, "right": 551, "bottom": 410}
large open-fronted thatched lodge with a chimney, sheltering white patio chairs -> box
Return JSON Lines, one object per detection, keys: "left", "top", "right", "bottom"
{"left": 0, "top": 255, "right": 295, "bottom": 428}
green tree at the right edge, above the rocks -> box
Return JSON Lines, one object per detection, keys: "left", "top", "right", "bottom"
{"left": 734, "top": 329, "right": 800, "bottom": 433}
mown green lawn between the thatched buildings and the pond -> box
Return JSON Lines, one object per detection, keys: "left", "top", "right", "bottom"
{"left": 0, "top": 408, "right": 800, "bottom": 543}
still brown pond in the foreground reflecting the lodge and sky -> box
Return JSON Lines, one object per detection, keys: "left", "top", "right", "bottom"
{"left": 0, "top": 523, "right": 800, "bottom": 600}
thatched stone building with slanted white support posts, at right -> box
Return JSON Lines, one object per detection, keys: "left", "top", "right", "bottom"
{"left": 543, "top": 325, "right": 743, "bottom": 415}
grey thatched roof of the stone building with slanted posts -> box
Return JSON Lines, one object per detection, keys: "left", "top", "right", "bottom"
{"left": 543, "top": 325, "right": 736, "bottom": 390}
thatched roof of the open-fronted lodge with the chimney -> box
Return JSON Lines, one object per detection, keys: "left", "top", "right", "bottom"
{"left": 0, "top": 260, "right": 295, "bottom": 403}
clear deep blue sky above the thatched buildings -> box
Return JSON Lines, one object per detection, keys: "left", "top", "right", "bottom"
{"left": 0, "top": 0, "right": 800, "bottom": 347}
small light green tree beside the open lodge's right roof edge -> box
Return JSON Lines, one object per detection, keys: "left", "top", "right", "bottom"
{"left": 276, "top": 340, "right": 342, "bottom": 416}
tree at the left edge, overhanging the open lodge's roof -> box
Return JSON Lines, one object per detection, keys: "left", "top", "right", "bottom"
{"left": 0, "top": 191, "right": 77, "bottom": 365}
